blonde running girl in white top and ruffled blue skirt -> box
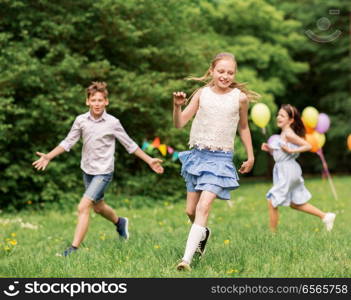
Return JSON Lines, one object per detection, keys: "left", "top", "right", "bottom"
{"left": 173, "top": 53, "right": 258, "bottom": 270}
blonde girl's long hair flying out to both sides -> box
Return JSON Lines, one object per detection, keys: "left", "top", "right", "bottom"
{"left": 187, "top": 52, "right": 261, "bottom": 101}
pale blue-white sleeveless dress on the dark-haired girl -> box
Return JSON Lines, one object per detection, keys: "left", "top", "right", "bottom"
{"left": 266, "top": 138, "right": 311, "bottom": 207}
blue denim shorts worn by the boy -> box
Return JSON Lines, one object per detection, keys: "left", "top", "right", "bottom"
{"left": 83, "top": 172, "right": 113, "bottom": 203}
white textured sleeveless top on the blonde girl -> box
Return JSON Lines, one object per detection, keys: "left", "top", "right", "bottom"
{"left": 189, "top": 87, "right": 240, "bottom": 151}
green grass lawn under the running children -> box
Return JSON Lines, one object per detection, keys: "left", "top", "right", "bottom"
{"left": 0, "top": 177, "right": 351, "bottom": 277}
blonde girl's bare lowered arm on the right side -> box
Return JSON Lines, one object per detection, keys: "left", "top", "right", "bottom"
{"left": 239, "top": 93, "right": 255, "bottom": 173}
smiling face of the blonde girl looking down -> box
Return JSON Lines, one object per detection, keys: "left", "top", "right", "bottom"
{"left": 212, "top": 59, "right": 236, "bottom": 92}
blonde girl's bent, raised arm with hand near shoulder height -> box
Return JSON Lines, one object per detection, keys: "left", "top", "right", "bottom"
{"left": 173, "top": 89, "right": 201, "bottom": 128}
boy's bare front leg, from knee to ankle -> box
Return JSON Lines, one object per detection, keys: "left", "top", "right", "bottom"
{"left": 72, "top": 197, "right": 93, "bottom": 248}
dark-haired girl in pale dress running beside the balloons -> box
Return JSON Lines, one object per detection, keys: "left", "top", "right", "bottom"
{"left": 261, "top": 104, "right": 335, "bottom": 231}
